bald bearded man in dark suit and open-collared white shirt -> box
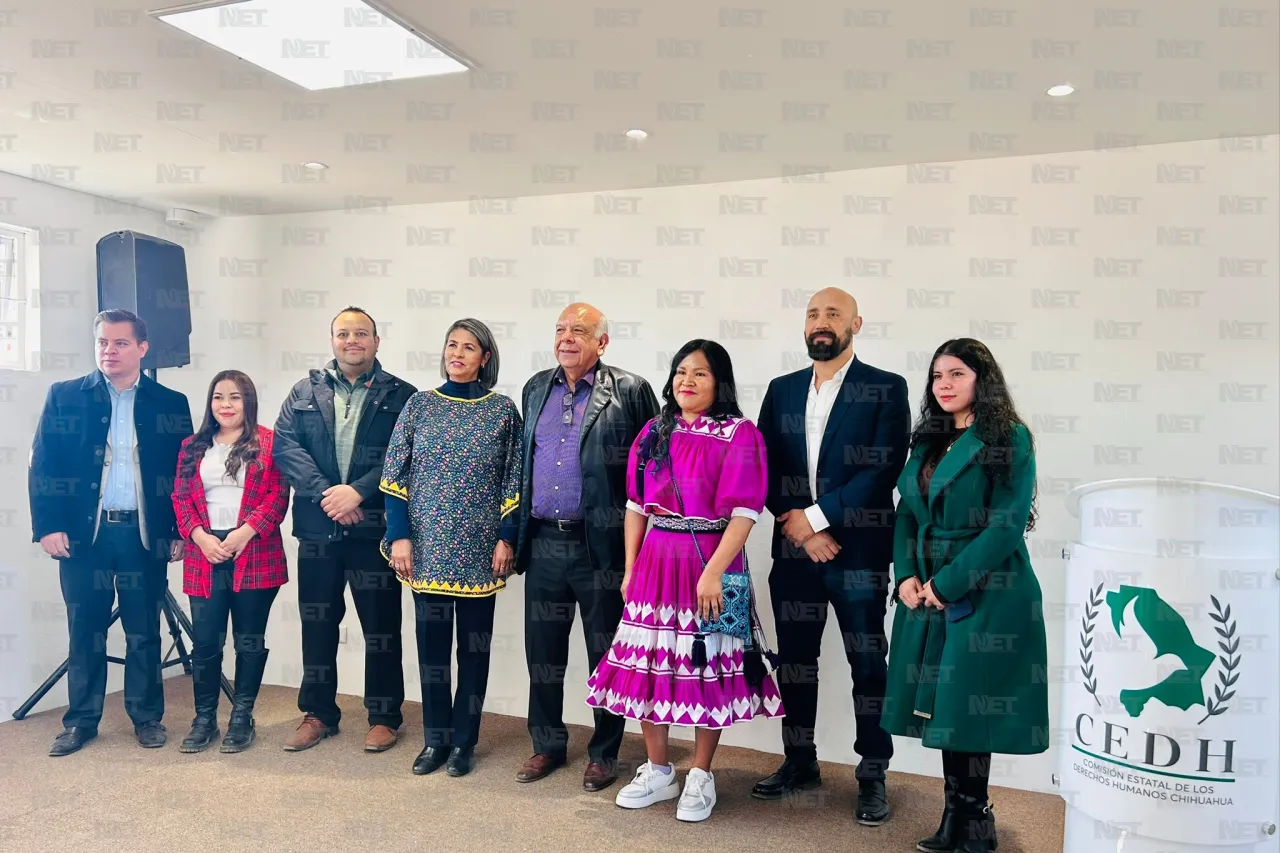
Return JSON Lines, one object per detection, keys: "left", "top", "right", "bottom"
{"left": 751, "top": 288, "right": 910, "bottom": 826}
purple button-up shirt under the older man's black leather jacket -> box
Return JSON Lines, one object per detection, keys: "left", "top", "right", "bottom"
{"left": 530, "top": 368, "right": 595, "bottom": 521}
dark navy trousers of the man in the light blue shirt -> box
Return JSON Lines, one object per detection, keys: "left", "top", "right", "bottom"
{"left": 58, "top": 520, "right": 169, "bottom": 729}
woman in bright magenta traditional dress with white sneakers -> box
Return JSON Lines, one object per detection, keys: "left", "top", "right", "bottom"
{"left": 586, "top": 339, "right": 782, "bottom": 821}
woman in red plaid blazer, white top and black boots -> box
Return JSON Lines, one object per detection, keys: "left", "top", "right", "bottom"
{"left": 173, "top": 370, "right": 289, "bottom": 752}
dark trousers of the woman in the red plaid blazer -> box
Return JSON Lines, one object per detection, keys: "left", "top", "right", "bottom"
{"left": 189, "top": 530, "right": 280, "bottom": 660}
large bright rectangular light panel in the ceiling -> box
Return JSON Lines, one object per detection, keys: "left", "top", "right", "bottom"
{"left": 151, "top": 0, "right": 467, "bottom": 91}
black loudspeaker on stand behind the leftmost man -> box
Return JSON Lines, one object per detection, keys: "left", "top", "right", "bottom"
{"left": 97, "top": 231, "right": 191, "bottom": 370}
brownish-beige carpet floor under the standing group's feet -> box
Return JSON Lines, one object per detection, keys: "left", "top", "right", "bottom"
{"left": 0, "top": 678, "right": 1062, "bottom": 853}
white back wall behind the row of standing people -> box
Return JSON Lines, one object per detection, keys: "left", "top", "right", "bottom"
{"left": 0, "top": 137, "right": 1280, "bottom": 790}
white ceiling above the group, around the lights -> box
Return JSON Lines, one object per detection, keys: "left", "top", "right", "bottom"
{"left": 0, "top": 0, "right": 1280, "bottom": 215}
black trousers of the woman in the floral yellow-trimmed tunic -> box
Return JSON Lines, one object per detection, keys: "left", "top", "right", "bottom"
{"left": 413, "top": 592, "right": 497, "bottom": 749}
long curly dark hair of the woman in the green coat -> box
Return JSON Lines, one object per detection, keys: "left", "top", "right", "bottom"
{"left": 911, "top": 338, "right": 1039, "bottom": 532}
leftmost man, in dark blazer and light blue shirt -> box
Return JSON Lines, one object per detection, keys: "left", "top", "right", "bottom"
{"left": 27, "top": 309, "right": 192, "bottom": 756}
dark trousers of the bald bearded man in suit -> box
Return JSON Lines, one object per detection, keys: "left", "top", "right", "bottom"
{"left": 769, "top": 558, "right": 893, "bottom": 781}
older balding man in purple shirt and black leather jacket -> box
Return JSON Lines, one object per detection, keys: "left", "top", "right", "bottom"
{"left": 516, "top": 304, "right": 658, "bottom": 792}
